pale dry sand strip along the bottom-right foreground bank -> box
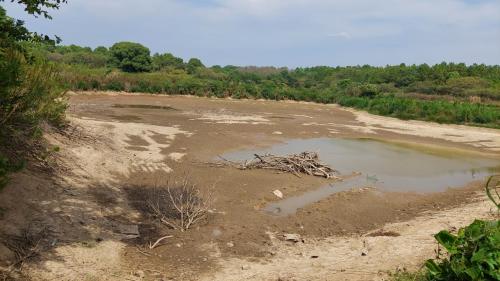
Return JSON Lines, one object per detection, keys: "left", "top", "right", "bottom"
{"left": 201, "top": 197, "right": 493, "bottom": 281}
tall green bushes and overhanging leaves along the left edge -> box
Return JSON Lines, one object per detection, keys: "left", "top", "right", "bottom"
{"left": 0, "top": 0, "right": 66, "bottom": 188}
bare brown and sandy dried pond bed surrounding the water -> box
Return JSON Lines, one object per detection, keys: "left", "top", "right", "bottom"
{"left": 0, "top": 93, "right": 500, "bottom": 280}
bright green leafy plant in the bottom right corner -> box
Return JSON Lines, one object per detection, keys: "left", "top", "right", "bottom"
{"left": 425, "top": 220, "right": 500, "bottom": 281}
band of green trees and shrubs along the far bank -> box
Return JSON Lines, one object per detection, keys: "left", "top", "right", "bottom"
{"left": 34, "top": 42, "right": 500, "bottom": 128}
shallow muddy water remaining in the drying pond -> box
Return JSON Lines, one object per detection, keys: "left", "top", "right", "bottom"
{"left": 224, "top": 138, "right": 500, "bottom": 215}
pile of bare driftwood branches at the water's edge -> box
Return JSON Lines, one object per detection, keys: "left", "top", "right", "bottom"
{"left": 212, "top": 151, "right": 340, "bottom": 179}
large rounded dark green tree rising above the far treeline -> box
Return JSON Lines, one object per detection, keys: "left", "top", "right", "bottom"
{"left": 109, "top": 42, "right": 151, "bottom": 72}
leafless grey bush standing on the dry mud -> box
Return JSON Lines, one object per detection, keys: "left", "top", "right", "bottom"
{"left": 147, "top": 177, "right": 213, "bottom": 231}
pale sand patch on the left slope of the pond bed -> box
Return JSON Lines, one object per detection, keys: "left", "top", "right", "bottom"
{"left": 59, "top": 117, "right": 191, "bottom": 182}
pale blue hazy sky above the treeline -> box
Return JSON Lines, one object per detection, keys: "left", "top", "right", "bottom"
{"left": 0, "top": 0, "right": 500, "bottom": 67}
